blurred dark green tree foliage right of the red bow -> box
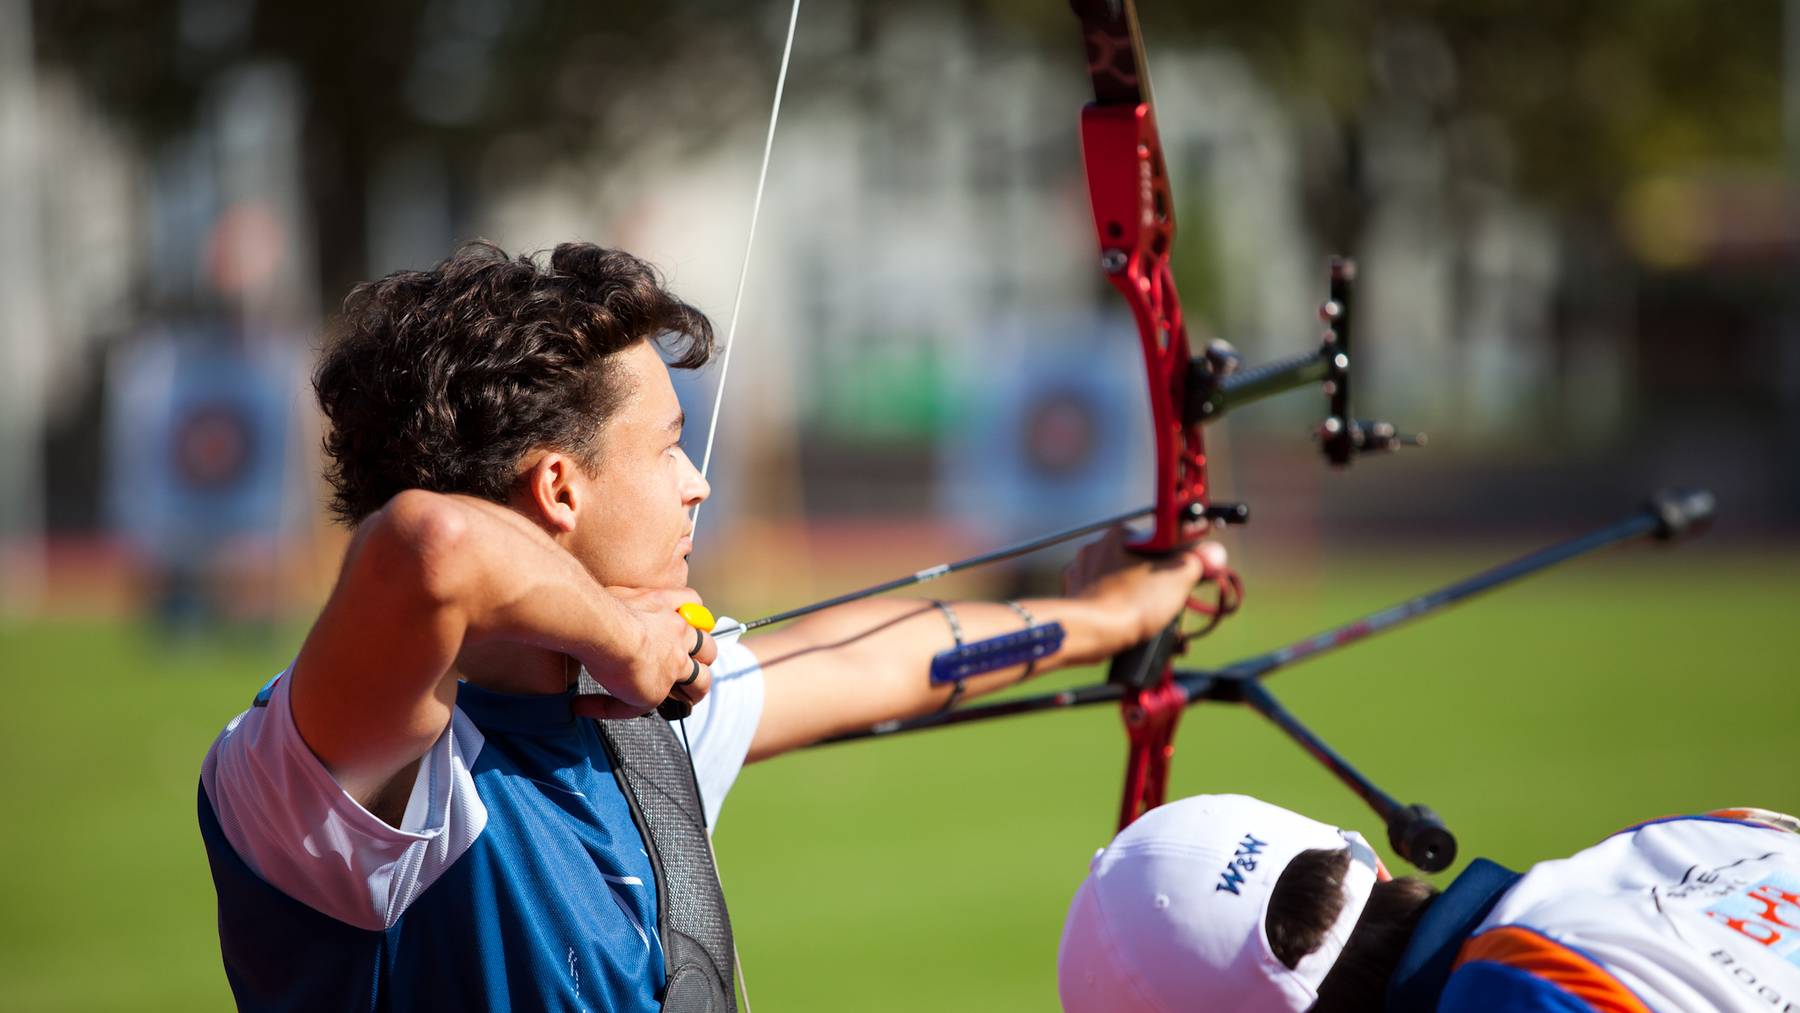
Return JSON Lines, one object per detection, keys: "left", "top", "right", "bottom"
{"left": 972, "top": 0, "right": 1782, "bottom": 248}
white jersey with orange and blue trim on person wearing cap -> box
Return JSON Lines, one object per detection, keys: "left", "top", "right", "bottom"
{"left": 1388, "top": 810, "right": 1800, "bottom": 1013}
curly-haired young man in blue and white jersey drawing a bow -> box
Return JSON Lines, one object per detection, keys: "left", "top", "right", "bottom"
{"left": 200, "top": 245, "right": 1220, "bottom": 1011}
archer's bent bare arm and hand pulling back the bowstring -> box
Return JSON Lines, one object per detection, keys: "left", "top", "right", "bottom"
{"left": 288, "top": 489, "right": 713, "bottom": 808}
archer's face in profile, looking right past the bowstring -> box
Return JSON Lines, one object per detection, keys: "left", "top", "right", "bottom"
{"left": 563, "top": 342, "right": 711, "bottom": 587}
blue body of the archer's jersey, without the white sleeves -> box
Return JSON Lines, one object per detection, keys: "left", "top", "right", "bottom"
{"left": 200, "top": 684, "right": 664, "bottom": 1013}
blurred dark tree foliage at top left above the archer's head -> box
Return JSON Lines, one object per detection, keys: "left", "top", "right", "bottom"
{"left": 36, "top": 0, "right": 792, "bottom": 306}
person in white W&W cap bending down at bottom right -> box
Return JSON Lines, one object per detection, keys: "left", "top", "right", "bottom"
{"left": 1057, "top": 795, "right": 1800, "bottom": 1013}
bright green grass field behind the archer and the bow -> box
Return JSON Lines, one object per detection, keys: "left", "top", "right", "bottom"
{"left": 0, "top": 545, "right": 1800, "bottom": 1013}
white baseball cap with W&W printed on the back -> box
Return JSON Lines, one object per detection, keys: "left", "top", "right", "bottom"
{"left": 1057, "top": 795, "right": 1388, "bottom": 1013}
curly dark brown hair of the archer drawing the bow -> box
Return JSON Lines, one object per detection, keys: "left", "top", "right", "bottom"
{"left": 313, "top": 243, "right": 715, "bottom": 525}
